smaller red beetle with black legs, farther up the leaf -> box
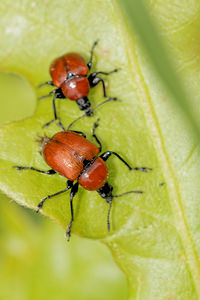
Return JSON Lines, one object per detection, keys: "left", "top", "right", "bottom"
{"left": 40, "top": 41, "right": 118, "bottom": 130}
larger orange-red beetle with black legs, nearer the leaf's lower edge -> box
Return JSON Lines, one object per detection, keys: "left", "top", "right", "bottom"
{"left": 14, "top": 122, "right": 151, "bottom": 240}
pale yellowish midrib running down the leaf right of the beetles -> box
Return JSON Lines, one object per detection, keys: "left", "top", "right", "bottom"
{"left": 113, "top": 1, "right": 200, "bottom": 298}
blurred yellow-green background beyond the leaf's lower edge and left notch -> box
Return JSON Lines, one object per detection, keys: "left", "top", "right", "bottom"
{"left": 0, "top": 73, "right": 128, "bottom": 300}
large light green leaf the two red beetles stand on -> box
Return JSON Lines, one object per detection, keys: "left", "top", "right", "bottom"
{"left": 0, "top": 0, "right": 200, "bottom": 300}
